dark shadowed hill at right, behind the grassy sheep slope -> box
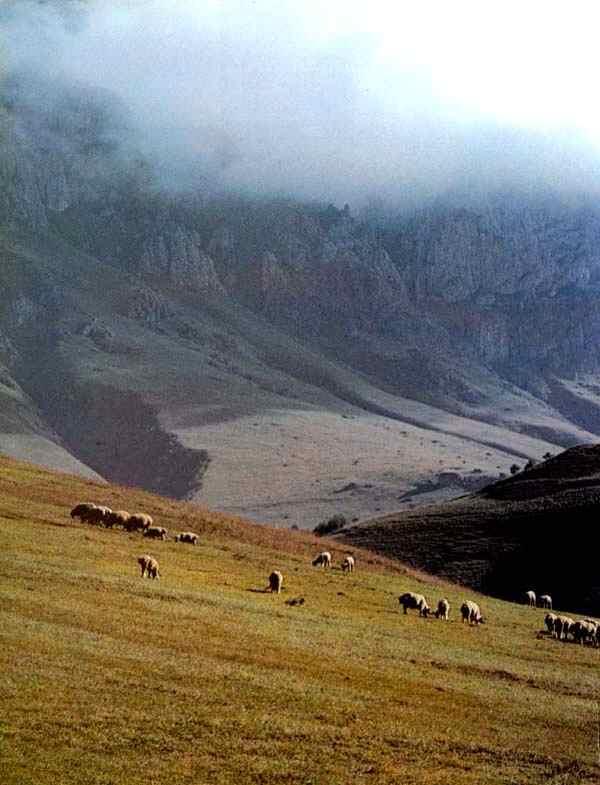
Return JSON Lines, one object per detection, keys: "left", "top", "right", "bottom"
{"left": 337, "top": 445, "right": 600, "bottom": 614}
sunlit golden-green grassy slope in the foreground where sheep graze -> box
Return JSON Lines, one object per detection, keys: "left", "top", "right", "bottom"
{"left": 0, "top": 459, "right": 600, "bottom": 785}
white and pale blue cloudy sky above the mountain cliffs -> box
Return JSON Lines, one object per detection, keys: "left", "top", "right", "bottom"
{"left": 3, "top": 0, "right": 600, "bottom": 203}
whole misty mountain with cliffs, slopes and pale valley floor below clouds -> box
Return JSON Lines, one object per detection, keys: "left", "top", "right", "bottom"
{"left": 0, "top": 76, "right": 600, "bottom": 526}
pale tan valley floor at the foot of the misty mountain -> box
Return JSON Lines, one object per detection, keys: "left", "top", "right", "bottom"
{"left": 175, "top": 404, "right": 568, "bottom": 529}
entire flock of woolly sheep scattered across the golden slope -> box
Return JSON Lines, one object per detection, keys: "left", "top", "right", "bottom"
{"left": 71, "top": 502, "right": 600, "bottom": 647}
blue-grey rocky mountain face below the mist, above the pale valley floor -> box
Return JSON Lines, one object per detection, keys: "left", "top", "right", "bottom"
{"left": 0, "top": 72, "right": 600, "bottom": 508}
